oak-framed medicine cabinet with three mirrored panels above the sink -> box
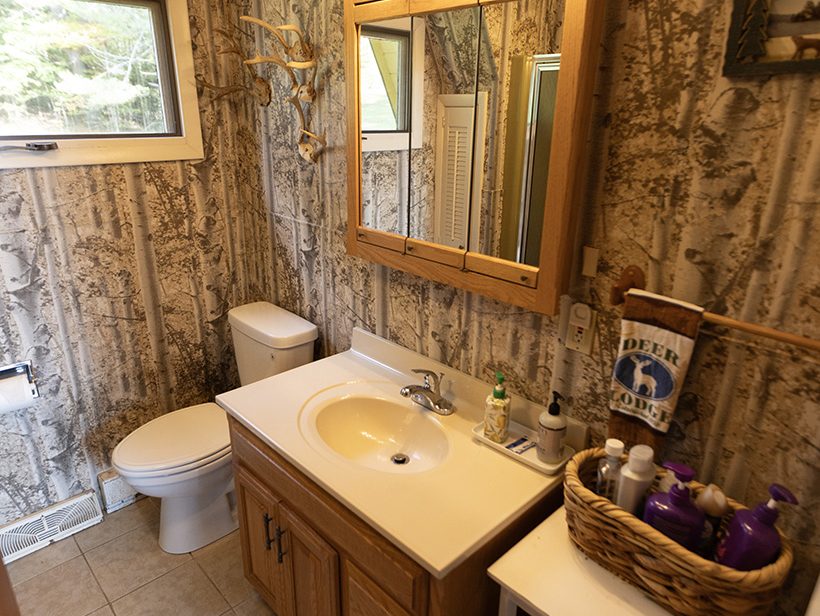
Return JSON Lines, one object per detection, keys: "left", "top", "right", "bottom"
{"left": 345, "top": 0, "right": 602, "bottom": 314}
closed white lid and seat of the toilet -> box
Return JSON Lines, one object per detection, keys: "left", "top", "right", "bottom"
{"left": 112, "top": 402, "right": 231, "bottom": 472}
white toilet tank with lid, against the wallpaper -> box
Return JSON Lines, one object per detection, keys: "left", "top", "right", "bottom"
{"left": 228, "top": 302, "right": 319, "bottom": 385}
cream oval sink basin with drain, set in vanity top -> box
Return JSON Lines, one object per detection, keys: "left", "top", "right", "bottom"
{"left": 303, "top": 393, "right": 450, "bottom": 473}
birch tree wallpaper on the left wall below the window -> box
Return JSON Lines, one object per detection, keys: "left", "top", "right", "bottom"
{"left": 0, "top": 2, "right": 272, "bottom": 523}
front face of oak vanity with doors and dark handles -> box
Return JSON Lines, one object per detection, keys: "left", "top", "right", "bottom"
{"left": 230, "top": 419, "right": 428, "bottom": 616}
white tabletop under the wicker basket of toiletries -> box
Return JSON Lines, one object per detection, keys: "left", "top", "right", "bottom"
{"left": 487, "top": 507, "right": 670, "bottom": 616}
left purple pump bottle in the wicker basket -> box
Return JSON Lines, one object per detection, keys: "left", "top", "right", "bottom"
{"left": 643, "top": 462, "right": 706, "bottom": 550}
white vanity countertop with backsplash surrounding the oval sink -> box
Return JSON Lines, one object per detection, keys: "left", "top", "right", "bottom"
{"left": 216, "top": 330, "right": 586, "bottom": 578}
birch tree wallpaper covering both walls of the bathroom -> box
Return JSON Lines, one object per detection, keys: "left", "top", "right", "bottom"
{"left": 0, "top": 0, "right": 820, "bottom": 615}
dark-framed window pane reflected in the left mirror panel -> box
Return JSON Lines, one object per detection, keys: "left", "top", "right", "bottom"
{"left": 359, "top": 26, "right": 410, "bottom": 132}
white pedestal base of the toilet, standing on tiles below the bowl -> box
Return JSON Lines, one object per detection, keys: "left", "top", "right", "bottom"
{"left": 159, "top": 492, "right": 238, "bottom": 554}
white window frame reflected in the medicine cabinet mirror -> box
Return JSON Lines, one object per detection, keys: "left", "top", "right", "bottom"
{"left": 362, "top": 17, "right": 425, "bottom": 152}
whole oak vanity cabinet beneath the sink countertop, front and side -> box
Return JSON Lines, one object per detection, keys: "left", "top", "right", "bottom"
{"left": 229, "top": 417, "right": 561, "bottom": 616}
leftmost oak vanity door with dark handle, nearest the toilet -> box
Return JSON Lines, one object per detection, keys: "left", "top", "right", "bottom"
{"left": 235, "top": 467, "right": 290, "bottom": 614}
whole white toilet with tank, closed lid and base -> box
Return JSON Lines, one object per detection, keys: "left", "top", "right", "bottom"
{"left": 111, "top": 302, "right": 318, "bottom": 554}
